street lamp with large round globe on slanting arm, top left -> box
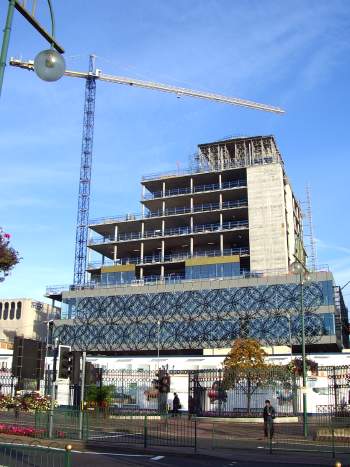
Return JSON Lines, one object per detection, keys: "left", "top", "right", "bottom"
{"left": 0, "top": 0, "right": 65, "bottom": 95}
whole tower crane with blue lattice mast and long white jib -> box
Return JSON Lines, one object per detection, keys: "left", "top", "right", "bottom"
{"left": 10, "top": 55, "right": 284, "bottom": 285}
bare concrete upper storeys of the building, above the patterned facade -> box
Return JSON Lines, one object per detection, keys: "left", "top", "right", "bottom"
{"left": 89, "top": 136, "right": 304, "bottom": 285}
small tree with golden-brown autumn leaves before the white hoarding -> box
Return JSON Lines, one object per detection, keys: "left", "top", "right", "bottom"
{"left": 224, "top": 339, "right": 270, "bottom": 413}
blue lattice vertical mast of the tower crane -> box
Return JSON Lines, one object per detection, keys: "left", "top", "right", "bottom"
{"left": 73, "top": 55, "right": 96, "bottom": 285}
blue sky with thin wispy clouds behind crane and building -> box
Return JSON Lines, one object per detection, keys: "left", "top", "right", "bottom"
{"left": 0, "top": 0, "right": 350, "bottom": 303}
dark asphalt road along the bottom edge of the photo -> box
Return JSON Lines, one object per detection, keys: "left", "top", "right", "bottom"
{"left": 0, "top": 440, "right": 350, "bottom": 467}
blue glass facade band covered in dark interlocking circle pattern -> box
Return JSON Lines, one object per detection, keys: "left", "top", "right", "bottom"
{"left": 55, "top": 283, "right": 330, "bottom": 351}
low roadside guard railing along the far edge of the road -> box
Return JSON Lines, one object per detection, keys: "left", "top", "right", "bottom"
{"left": 1, "top": 409, "right": 350, "bottom": 458}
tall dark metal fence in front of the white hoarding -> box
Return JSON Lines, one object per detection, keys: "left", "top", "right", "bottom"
{"left": 70, "top": 366, "right": 350, "bottom": 417}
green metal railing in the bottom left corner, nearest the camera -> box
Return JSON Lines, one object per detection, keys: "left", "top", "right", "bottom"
{"left": 0, "top": 440, "right": 72, "bottom": 467}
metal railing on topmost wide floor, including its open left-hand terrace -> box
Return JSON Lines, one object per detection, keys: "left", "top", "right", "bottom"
{"left": 89, "top": 199, "right": 248, "bottom": 225}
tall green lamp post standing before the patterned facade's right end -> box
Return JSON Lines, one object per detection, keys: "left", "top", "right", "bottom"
{"left": 291, "top": 261, "right": 310, "bottom": 437}
